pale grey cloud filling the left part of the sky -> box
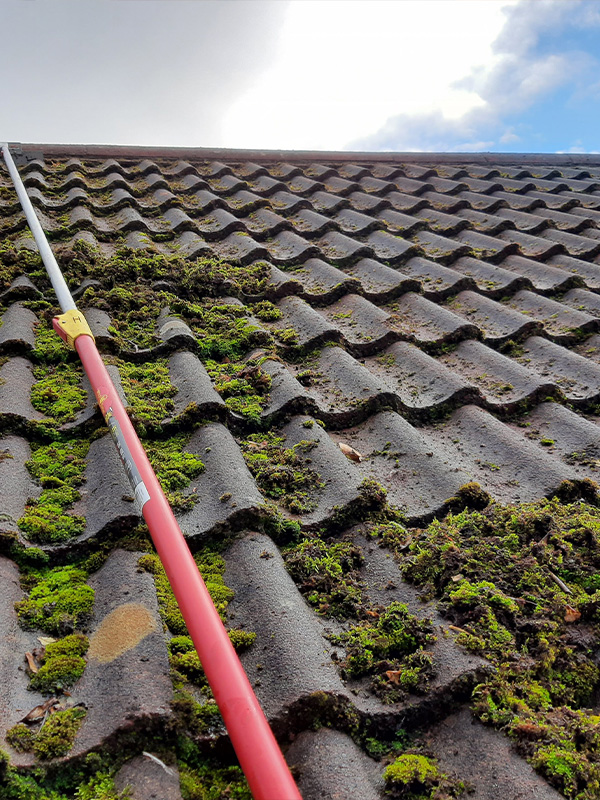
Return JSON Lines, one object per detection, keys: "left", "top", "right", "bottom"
{"left": 0, "top": 0, "right": 287, "bottom": 146}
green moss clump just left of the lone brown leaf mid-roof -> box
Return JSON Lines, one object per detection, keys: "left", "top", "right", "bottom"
{"left": 241, "top": 433, "right": 325, "bottom": 515}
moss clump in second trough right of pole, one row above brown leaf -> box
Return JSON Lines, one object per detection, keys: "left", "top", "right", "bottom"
{"left": 206, "top": 360, "right": 271, "bottom": 421}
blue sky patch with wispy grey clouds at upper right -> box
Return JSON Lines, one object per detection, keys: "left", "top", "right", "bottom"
{"left": 349, "top": 0, "right": 600, "bottom": 152}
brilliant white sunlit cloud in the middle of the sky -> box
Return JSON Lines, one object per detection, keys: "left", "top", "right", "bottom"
{"left": 222, "top": 0, "right": 512, "bottom": 149}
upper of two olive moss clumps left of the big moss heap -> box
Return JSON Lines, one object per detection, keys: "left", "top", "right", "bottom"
{"left": 283, "top": 537, "right": 365, "bottom": 619}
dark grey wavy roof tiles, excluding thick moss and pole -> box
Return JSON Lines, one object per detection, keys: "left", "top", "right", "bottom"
{"left": 0, "top": 146, "right": 600, "bottom": 800}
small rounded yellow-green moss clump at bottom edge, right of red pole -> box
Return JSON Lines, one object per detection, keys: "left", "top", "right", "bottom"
{"left": 383, "top": 753, "right": 465, "bottom": 800}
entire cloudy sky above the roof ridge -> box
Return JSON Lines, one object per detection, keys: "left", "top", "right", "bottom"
{"left": 0, "top": 0, "right": 600, "bottom": 153}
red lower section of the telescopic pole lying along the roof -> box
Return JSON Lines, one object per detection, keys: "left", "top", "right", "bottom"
{"left": 72, "top": 332, "right": 302, "bottom": 800}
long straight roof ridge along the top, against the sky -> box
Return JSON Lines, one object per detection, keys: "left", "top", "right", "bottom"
{"left": 9, "top": 142, "right": 600, "bottom": 166}
